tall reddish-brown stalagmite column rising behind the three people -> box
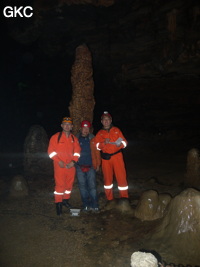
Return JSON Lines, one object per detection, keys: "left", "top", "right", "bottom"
{"left": 69, "top": 44, "right": 95, "bottom": 134}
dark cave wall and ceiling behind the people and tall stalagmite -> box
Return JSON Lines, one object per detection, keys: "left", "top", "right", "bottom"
{"left": 0, "top": 0, "right": 200, "bottom": 158}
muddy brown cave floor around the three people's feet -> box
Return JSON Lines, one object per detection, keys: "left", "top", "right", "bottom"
{"left": 0, "top": 140, "right": 199, "bottom": 267}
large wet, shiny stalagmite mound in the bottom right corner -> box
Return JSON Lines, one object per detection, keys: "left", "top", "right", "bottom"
{"left": 145, "top": 188, "right": 200, "bottom": 266}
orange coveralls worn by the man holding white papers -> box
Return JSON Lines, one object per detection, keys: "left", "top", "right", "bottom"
{"left": 95, "top": 126, "right": 128, "bottom": 200}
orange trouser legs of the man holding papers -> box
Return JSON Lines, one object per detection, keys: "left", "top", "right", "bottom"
{"left": 102, "top": 153, "right": 128, "bottom": 200}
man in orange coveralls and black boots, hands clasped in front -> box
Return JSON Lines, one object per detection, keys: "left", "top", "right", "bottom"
{"left": 48, "top": 117, "right": 81, "bottom": 215}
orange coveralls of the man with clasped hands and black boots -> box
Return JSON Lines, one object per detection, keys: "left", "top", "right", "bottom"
{"left": 48, "top": 132, "right": 81, "bottom": 203}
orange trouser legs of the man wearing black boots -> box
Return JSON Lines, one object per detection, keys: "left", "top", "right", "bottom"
{"left": 54, "top": 162, "right": 75, "bottom": 203}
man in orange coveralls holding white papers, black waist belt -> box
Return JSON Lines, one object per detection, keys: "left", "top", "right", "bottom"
{"left": 95, "top": 111, "right": 128, "bottom": 205}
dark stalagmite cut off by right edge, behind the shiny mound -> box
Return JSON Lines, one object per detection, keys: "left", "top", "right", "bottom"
{"left": 184, "top": 148, "right": 200, "bottom": 189}
